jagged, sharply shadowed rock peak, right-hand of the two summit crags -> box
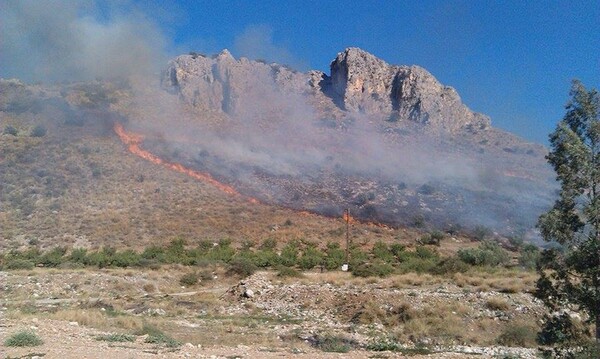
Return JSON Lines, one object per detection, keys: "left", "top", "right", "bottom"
{"left": 331, "top": 47, "right": 490, "bottom": 131}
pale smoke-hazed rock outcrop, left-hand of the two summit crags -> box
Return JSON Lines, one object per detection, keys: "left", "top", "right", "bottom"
{"left": 162, "top": 50, "right": 309, "bottom": 116}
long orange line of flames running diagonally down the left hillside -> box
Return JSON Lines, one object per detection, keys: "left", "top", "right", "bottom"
{"left": 113, "top": 122, "right": 258, "bottom": 203}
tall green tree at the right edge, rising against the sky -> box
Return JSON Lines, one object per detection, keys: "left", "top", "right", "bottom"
{"left": 536, "top": 80, "right": 600, "bottom": 343}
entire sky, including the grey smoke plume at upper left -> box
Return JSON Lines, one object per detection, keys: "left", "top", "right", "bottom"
{"left": 0, "top": 0, "right": 600, "bottom": 144}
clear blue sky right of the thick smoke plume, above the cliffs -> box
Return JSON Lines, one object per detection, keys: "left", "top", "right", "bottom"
{"left": 159, "top": 0, "right": 600, "bottom": 143}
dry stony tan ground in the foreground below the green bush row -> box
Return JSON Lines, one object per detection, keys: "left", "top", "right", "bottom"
{"left": 0, "top": 267, "right": 542, "bottom": 358}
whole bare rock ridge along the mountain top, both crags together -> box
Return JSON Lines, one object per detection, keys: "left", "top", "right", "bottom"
{"left": 162, "top": 48, "right": 490, "bottom": 132}
